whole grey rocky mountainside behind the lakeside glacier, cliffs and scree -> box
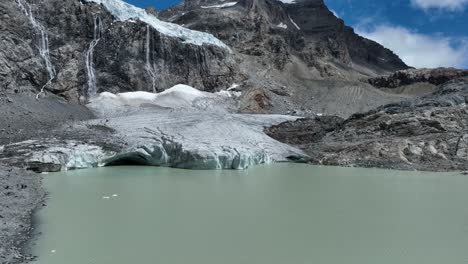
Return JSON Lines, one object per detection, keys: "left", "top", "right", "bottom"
{"left": 0, "top": 0, "right": 414, "bottom": 117}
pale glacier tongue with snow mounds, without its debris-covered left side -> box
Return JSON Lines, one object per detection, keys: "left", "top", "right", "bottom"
{"left": 87, "top": 84, "right": 305, "bottom": 169}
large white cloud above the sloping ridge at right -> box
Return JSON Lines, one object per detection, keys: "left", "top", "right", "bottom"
{"left": 356, "top": 25, "right": 468, "bottom": 68}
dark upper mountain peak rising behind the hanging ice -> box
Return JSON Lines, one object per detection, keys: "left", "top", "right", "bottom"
{"left": 159, "top": 0, "right": 408, "bottom": 77}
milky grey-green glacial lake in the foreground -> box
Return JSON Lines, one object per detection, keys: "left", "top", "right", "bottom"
{"left": 31, "top": 164, "right": 468, "bottom": 264}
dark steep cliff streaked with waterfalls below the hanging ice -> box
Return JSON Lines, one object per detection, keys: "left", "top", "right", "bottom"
{"left": 0, "top": 0, "right": 236, "bottom": 101}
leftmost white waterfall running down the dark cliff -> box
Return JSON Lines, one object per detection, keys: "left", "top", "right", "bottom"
{"left": 16, "top": 0, "right": 56, "bottom": 98}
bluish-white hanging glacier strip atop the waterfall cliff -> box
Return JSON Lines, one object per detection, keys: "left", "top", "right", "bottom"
{"left": 86, "top": 0, "right": 230, "bottom": 50}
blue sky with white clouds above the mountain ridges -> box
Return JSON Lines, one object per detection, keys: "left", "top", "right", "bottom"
{"left": 126, "top": 0, "right": 468, "bottom": 68}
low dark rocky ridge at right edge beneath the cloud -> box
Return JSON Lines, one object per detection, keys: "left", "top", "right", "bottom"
{"left": 368, "top": 68, "right": 468, "bottom": 88}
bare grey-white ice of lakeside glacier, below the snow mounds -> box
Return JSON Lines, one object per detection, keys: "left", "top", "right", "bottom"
{"left": 96, "top": 110, "right": 304, "bottom": 169}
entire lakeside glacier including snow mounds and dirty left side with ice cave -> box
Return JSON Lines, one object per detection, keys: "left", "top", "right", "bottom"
{"left": 0, "top": 84, "right": 306, "bottom": 171}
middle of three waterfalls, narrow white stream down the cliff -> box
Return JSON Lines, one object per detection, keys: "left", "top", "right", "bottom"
{"left": 85, "top": 17, "right": 102, "bottom": 98}
